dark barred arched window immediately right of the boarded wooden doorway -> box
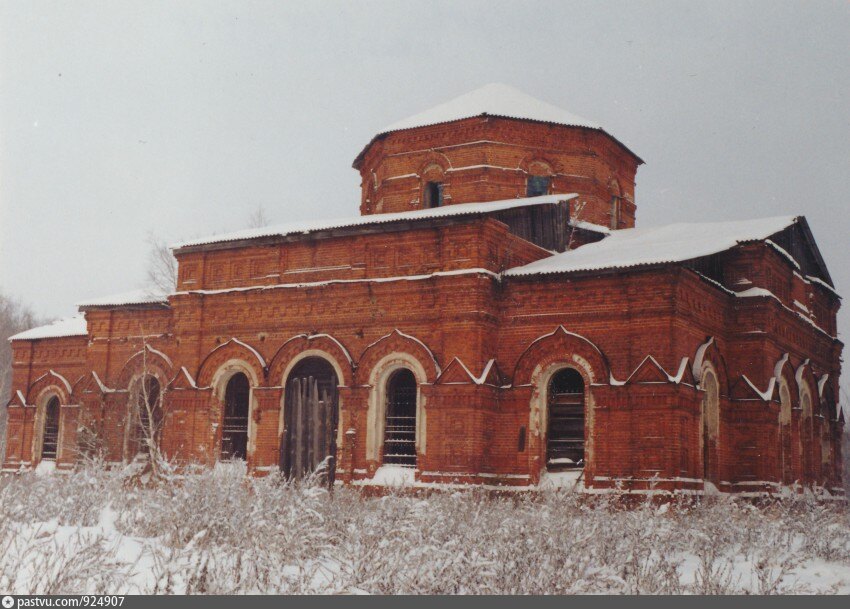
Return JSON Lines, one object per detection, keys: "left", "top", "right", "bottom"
{"left": 384, "top": 368, "right": 416, "bottom": 467}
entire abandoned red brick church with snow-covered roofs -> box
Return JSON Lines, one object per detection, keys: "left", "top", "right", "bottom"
{"left": 3, "top": 85, "right": 844, "bottom": 495}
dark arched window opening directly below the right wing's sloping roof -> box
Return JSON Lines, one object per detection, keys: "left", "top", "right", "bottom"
{"left": 546, "top": 368, "right": 585, "bottom": 471}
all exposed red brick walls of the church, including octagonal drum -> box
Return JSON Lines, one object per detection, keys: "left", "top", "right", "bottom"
{"left": 4, "top": 117, "right": 843, "bottom": 492}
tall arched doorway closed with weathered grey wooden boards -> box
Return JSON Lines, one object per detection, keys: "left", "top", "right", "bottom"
{"left": 280, "top": 357, "right": 339, "bottom": 483}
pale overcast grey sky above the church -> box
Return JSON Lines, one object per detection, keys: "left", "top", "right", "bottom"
{"left": 0, "top": 0, "right": 850, "bottom": 329}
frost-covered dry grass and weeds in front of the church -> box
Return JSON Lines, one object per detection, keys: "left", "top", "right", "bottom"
{"left": 0, "top": 468, "right": 850, "bottom": 594}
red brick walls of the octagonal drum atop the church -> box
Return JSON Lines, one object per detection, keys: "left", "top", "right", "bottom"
{"left": 357, "top": 117, "right": 640, "bottom": 228}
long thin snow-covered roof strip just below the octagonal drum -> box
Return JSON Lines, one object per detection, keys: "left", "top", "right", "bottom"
{"left": 171, "top": 194, "right": 577, "bottom": 249}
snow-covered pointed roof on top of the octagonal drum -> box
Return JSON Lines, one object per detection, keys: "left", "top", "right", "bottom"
{"left": 381, "top": 83, "right": 601, "bottom": 133}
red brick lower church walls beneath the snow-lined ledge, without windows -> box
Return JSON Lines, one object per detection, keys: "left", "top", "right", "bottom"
{"left": 6, "top": 252, "right": 840, "bottom": 490}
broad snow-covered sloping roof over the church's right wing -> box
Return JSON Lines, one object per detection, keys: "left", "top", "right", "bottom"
{"left": 505, "top": 216, "right": 799, "bottom": 276}
